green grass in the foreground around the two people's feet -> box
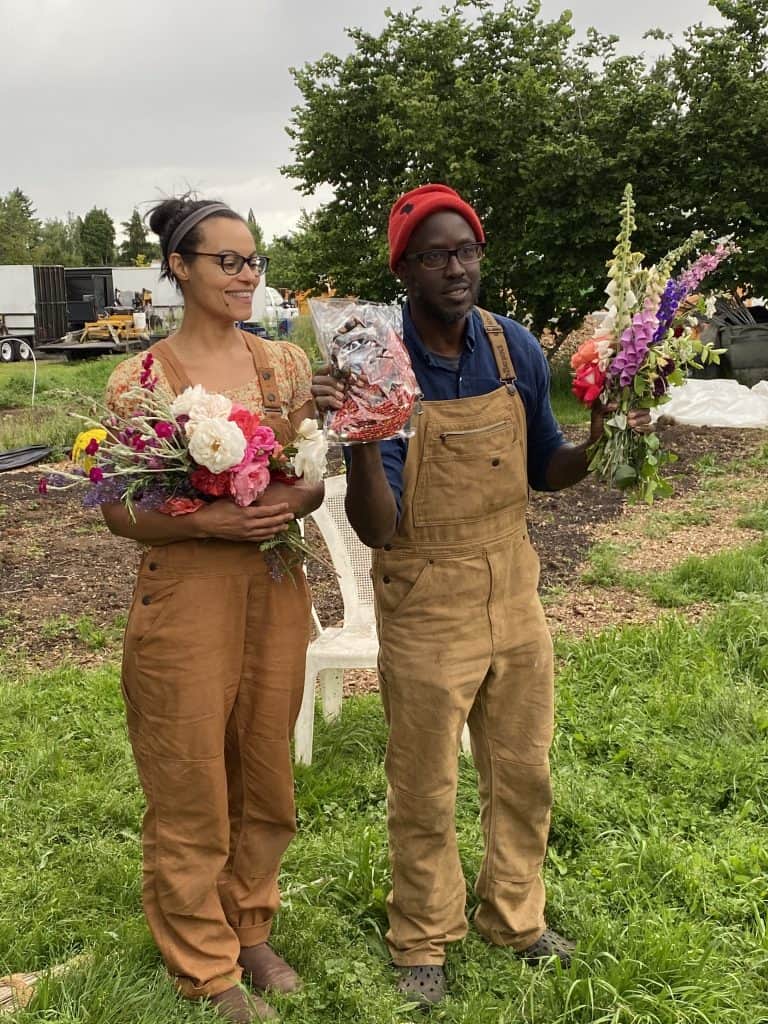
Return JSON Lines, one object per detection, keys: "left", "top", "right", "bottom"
{"left": 0, "top": 546, "right": 768, "bottom": 1024}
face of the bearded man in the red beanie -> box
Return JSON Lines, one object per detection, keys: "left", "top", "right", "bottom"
{"left": 397, "top": 210, "right": 480, "bottom": 324}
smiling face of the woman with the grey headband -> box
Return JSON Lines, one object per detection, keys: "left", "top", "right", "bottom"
{"left": 176, "top": 217, "right": 259, "bottom": 321}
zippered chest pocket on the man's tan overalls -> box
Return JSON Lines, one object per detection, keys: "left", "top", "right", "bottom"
{"left": 413, "top": 420, "right": 527, "bottom": 526}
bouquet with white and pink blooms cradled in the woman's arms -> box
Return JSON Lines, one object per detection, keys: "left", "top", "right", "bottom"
{"left": 40, "top": 352, "right": 328, "bottom": 577}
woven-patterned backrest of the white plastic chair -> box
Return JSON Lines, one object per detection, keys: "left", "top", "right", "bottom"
{"left": 311, "top": 474, "right": 374, "bottom": 626}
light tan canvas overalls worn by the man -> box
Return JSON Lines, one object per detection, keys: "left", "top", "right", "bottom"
{"left": 373, "top": 312, "right": 553, "bottom": 967}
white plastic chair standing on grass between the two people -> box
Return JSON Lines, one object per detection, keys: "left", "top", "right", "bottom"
{"left": 294, "top": 475, "right": 379, "bottom": 764}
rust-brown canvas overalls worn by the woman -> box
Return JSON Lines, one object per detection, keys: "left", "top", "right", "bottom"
{"left": 123, "top": 335, "right": 310, "bottom": 998}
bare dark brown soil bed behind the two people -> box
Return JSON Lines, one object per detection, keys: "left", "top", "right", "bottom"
{"left": 0, "top": 426, "right": 766, "bottom": 665}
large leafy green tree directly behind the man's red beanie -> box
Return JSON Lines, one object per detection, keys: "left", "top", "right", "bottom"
{"left": 285, "top": 0, "right": 768, "bottom": 336}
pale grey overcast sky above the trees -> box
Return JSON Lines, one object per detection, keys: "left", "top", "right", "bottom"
{"left": 0, "top": 0, "right": 719, "bottom": 239}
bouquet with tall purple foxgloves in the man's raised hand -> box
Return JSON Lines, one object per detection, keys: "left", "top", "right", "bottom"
{"left": 571, "top": 185, "right": 738, "bottom": 503}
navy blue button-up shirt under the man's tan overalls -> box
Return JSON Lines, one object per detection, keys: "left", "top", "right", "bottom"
{"left": 370, "top": 305, "right": 566, "bottom": 513}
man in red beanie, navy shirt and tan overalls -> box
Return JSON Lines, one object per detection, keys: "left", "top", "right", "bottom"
{"left": 312, "top": 184, "right": 649, "bottom": 1004}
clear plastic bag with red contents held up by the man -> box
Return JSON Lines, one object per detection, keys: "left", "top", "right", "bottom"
{"left": 309, "top": 299, "right": 420, "bottom": 444}
